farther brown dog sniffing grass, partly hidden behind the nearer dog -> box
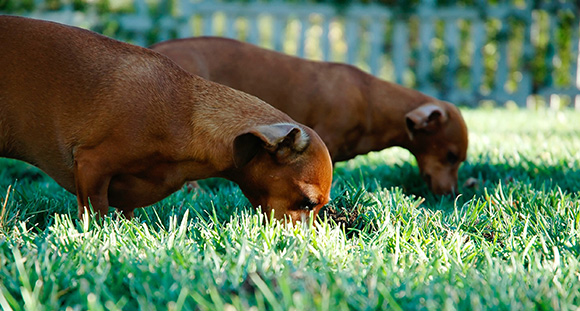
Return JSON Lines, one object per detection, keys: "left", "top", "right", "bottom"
{"left": 151, "top": 37, "right": 468, "bottom": 194}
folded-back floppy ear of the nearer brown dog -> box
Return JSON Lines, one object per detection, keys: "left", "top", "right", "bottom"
{"left": 234, "top": 123, "right": 310, "bottom": 167}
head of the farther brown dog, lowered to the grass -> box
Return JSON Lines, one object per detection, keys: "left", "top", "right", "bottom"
{"left": 405, "top": 101, "right": 468, "bottom": 194}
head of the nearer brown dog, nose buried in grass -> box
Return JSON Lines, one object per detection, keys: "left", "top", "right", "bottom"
{"left": 233, "top": 123, "right": 332, "bottom": 222}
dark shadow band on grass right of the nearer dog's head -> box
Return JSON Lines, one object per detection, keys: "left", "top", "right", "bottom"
{"left": 321, "top": 156, "right": 580, "bottom": 235}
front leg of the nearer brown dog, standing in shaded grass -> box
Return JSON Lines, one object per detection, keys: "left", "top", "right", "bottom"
{"left": 74, "top": 158, "right": 111, "bottom": 219}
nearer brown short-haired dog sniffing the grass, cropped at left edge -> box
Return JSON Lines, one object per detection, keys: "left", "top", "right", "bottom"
{"left": 0, "top": 16, "right": 332, "bottom": 220}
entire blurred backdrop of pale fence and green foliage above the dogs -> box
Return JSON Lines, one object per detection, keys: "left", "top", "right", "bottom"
{"left": 0, "top": 0, "right": 580, "bottom": 109}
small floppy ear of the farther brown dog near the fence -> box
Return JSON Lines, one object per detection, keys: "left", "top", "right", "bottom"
{"left": 405, "top": 103, "right": 448, "bottom": 140}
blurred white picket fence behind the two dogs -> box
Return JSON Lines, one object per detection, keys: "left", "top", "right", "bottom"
{"left": 19, "top": 0, "right": 580, "bottom": 109}
